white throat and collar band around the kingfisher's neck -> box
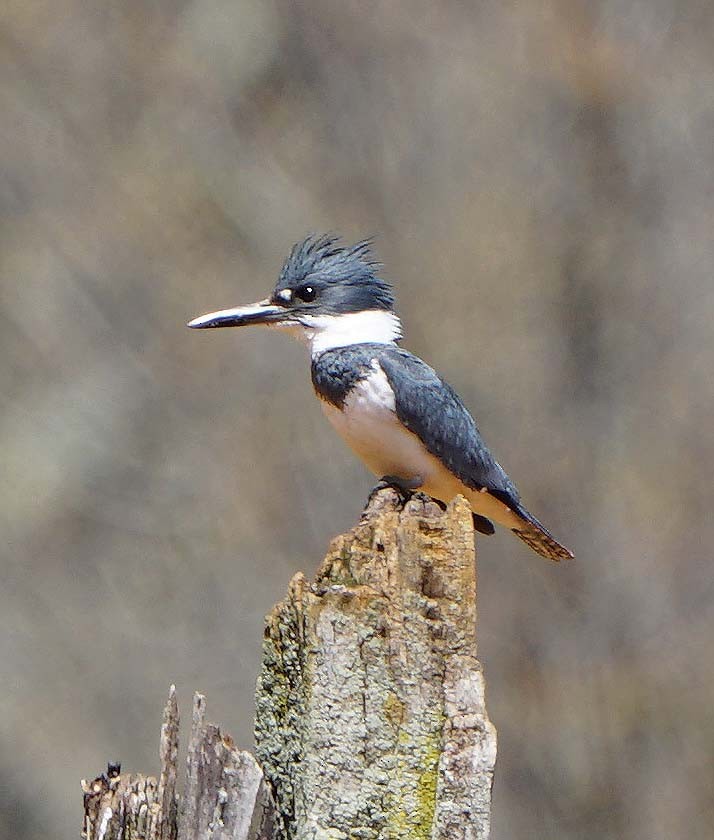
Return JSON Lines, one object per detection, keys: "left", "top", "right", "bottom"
{"left": 300, "top": 309, "right": 402, "bottom": 356}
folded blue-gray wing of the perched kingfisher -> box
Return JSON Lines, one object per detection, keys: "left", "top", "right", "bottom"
{"left": 379, "top": 347, "right": 519, "bottom": 509}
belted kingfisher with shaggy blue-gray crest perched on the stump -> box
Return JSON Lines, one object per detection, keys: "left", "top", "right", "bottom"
{"left": 188, "top": 236, "right": 573, "bottom": 560}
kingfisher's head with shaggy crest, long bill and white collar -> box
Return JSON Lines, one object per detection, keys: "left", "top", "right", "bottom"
{"left": 188, "top": 236, "right": 401, "bottom": 354}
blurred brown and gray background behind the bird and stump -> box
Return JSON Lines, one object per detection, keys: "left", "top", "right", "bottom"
{"left": 0, "top": 0, "right": 714, "bottom": 840}
